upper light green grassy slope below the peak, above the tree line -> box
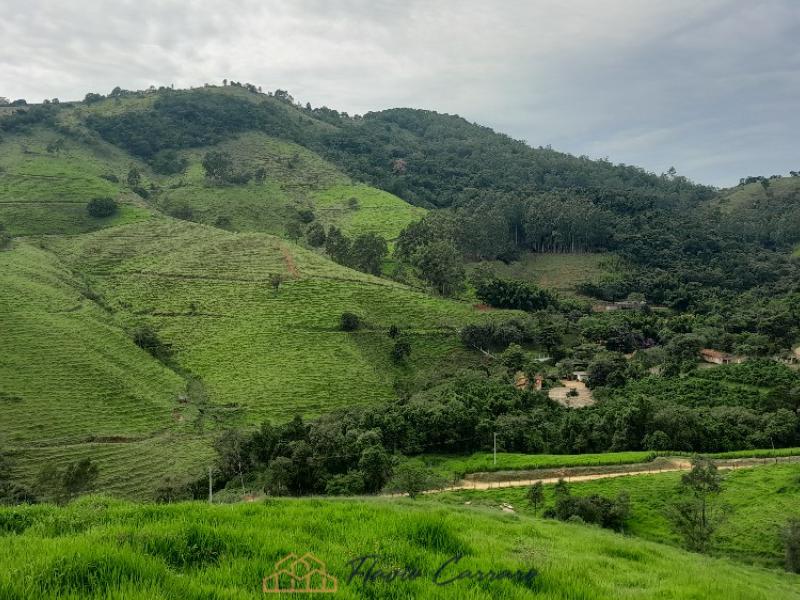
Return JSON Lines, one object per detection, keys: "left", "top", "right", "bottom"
{"left": 153, "top": 132, "right": 425, "bottom": 241}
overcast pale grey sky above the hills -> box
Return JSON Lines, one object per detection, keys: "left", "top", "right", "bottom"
{"left": 0, "top": 0, "right": 800, "bottom": 186}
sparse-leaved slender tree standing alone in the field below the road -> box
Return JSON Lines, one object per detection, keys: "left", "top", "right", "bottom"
{"left": 670, "top": 458, "right": 724, "bottom": 552}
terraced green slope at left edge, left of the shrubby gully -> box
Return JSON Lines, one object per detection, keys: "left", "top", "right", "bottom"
{"left": 0, "top": 242, "right": 210, "bottom": 495}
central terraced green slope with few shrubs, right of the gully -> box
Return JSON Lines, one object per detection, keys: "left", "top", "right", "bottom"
{"left": 43, "top": 220, "right": 500, "bottom": 422}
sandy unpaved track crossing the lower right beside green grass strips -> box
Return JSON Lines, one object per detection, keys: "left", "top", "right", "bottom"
{"left": 423, "top": 456, "right": 800, "bottom": 494}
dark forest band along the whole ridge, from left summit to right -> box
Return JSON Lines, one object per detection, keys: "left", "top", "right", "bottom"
{"left": 40, "top": 86, "right": 713, "bottom": 208}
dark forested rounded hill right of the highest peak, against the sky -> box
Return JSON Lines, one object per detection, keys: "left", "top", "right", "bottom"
{"left": 312, "top": 108, "right": 712, "bottom": 207}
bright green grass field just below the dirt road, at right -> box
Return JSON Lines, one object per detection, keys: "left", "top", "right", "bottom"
{"left": 432, "top": 463, "right": 800, "bottom": 568}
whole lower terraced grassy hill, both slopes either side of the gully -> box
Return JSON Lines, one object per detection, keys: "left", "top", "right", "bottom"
{"left": 0, "top": 217, "right": 510, "bottom": 497}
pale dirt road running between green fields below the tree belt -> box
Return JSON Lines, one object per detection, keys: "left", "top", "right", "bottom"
{"left": 423, "top": 456, "right": 800, "bottom": 494}
